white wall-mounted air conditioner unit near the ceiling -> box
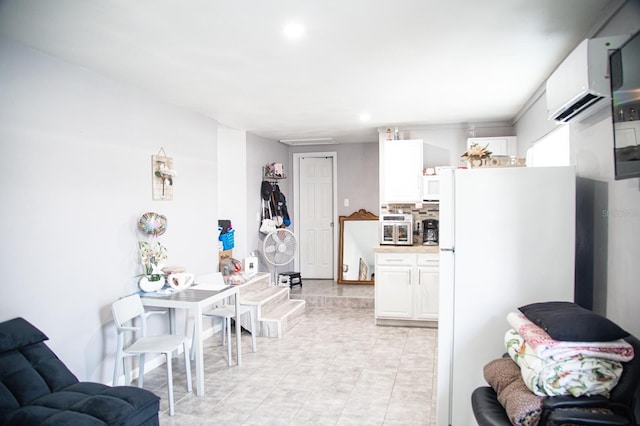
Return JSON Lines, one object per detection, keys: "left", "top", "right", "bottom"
{"left": 546, "top": 36, "right": 628, "bottom": 122}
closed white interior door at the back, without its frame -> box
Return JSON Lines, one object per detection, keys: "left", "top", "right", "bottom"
{"left": 297, "top": 157, "right": 334, "bottom": 279}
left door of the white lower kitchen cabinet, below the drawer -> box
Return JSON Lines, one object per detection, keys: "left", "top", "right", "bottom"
{"left": 375, "top": 265, "right": 413, "bottom": 319}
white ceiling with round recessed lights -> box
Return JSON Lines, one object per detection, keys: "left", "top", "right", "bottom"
{"left": 0, "top": 0, "right": 621, "bottom": 143}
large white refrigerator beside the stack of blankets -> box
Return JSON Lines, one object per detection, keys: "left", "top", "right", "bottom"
{"left": 437, "top": 167, "right": 576, "bottom": 426}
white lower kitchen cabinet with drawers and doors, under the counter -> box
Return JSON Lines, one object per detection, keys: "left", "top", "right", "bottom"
{"left": 375, "top": 253, "right": 439, "bottom": 325}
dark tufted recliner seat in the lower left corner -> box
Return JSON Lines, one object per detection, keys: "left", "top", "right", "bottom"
{"left": 0, "top": 318, "right": 160, "bottom": 426}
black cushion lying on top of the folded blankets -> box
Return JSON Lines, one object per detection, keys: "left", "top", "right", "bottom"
{"left": 518, "top": 302, "right": 629, "bottom": 342}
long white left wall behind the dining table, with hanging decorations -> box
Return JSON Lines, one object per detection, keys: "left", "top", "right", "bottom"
{"left": 0, "top": 38, "right": 218, "bottom": 383}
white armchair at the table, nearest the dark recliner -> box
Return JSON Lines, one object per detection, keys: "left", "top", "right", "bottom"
{"left": 111, "top": 294, "right": 191, "bottom": 416}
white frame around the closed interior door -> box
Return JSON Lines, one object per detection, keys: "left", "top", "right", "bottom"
{"left": 293, "top": 151, "right": 338, "bottom": 281}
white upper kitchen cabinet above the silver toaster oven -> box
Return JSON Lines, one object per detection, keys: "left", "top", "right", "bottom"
{"left": 380, "top": 139, "right": 423, "bottom": 204}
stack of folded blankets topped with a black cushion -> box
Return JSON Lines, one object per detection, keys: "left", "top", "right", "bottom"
{"left": 484, "top": 302, "right": 634, "bottom": 425}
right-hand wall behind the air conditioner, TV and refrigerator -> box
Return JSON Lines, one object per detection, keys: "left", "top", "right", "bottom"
{"left": 516, "top": 1, "right": 640, "bottom": 336}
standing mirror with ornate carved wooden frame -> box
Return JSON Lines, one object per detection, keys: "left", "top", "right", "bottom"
{"left": 338, "top": 209, "right": 378, "bottom": 284}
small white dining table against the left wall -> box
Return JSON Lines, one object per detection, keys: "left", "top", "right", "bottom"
{"left": 140, "top": 286, "right": 242, "bottom": 396}
